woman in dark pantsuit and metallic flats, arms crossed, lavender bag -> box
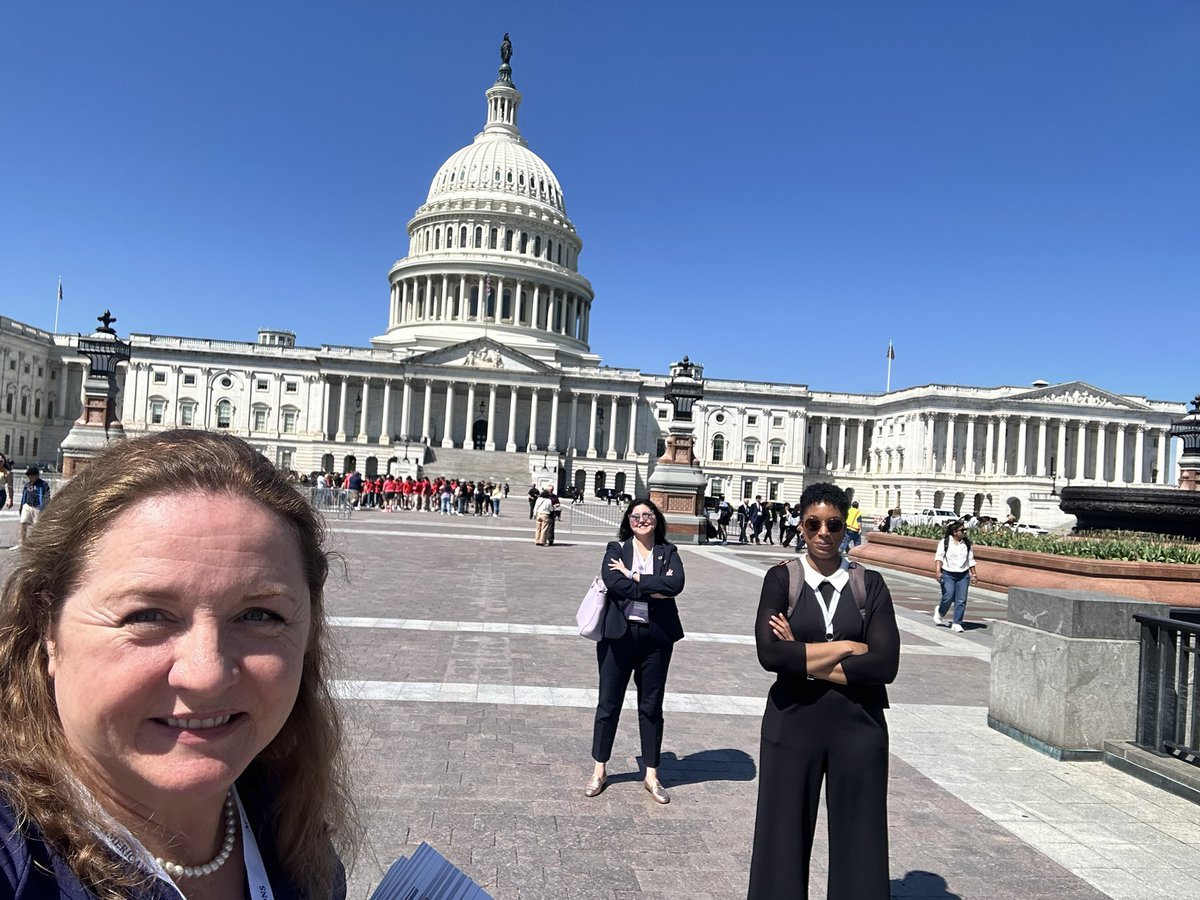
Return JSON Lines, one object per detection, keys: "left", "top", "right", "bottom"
{"left": 583, "top": 499, "right": 683, "bottom": 803}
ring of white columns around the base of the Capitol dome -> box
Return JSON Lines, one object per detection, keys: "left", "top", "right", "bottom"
{"left": 390, "top": 274, "right": 592, "bottom": 342}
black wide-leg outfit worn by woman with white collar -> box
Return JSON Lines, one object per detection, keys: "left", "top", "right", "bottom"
{"left": 749, "top": 565, "right": 900, "bottom": 900}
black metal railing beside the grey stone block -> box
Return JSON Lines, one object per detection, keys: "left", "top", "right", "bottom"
{"left": 1134, "top": 614, "right": 1200, "bottom": 766}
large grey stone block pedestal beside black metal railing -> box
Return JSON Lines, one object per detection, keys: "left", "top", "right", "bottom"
{"left": 988, "top": 588, "right": 1162, "bottom": 761}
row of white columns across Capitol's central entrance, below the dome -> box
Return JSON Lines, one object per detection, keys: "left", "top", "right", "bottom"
{"left": 320, "top": 378, "right": 637, "bottom": 460}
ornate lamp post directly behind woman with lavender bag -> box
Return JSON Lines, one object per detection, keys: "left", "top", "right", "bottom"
{"left": 648, "top": 356, "right": 708, "bottom": 544}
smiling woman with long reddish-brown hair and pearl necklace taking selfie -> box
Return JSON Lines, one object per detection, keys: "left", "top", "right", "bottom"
{"left": 0, "top": 431, "right": 358, "bottom": 900}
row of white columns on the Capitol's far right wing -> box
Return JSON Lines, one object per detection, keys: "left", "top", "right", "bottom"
{"left": 923, "top": 413, "right": 1170, "bottom": 484}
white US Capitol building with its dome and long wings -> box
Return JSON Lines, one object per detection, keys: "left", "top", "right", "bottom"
{"left": 0, "top": 36, "right": 1186, "bottom": 526}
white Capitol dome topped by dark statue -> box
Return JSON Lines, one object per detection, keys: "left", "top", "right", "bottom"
{"left": 373, "top": 40, "right": 599, "bottom": 365}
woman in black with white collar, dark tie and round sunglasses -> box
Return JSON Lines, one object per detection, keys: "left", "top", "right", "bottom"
{"left": 749, "top": 484, "right": 900, "bottom": 900}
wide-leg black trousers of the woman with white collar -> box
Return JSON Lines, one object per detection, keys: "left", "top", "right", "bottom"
{"left": 749, "top": 691, "right": 890, "bottom": 900}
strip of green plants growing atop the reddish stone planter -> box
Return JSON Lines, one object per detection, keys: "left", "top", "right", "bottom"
{"left": 894, "top": 526, "right": 1200, "bottom": 565}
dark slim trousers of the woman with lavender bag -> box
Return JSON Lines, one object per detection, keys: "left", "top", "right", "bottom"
{"left": 592, "top": 622, "right": 674, "bottom": 768}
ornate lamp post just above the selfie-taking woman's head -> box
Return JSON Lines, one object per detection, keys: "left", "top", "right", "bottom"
{"left": 61, "top": 310, "right": 131, "bottom": 478}
